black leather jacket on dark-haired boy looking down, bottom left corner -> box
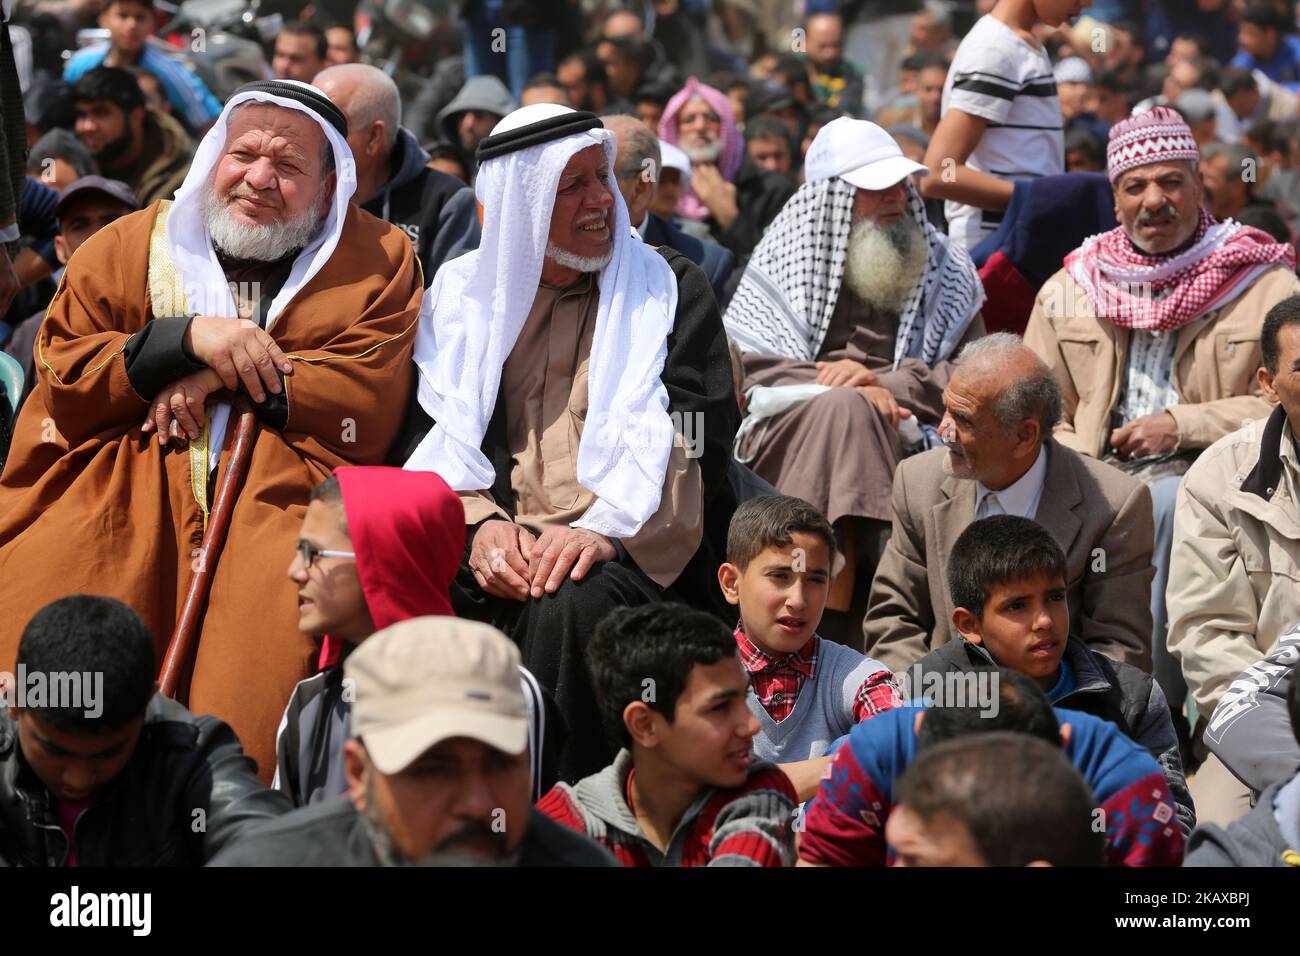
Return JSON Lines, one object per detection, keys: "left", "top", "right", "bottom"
{"left": 0, "top": 695, "right": 290, "bottom": 866}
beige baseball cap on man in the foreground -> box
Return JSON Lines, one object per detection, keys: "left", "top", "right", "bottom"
{"left": 343, "top": 617, "right": 528, "bottom": 774}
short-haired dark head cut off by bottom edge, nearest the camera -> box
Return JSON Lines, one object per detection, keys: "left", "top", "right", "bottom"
{"left": 885, "top": 731, "right": 1106, "bottom": 866}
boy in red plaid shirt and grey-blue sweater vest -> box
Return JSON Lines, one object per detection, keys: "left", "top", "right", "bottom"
{"left": 718, "top": 496, "right": 902, "bottom": 800}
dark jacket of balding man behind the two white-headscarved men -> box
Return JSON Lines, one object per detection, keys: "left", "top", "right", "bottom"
{"left": 361, "top": 127, "right": 482, "bottom": 289}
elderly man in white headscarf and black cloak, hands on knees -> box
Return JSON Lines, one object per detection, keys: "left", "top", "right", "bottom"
{"left": 406, "top": 103, "right": 737, "bottom": 780}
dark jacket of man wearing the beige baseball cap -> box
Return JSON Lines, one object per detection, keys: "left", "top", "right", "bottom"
{"left": 212, "top": 797, "right": 616, "bottom": 866}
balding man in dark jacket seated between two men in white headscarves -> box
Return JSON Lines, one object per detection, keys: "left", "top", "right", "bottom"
{"left": 312, "top": 64, "right": 480, "bottom": 287}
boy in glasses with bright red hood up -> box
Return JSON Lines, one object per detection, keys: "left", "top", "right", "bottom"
{"left": 272, "top": 467, "right": 560, "bottom": 806}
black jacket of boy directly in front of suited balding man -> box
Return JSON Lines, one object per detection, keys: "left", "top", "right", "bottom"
{"left": 907, "top": 637, "right": 1196, "bottom": 836}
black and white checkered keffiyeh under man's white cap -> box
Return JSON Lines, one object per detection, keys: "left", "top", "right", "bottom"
{"left": 723, "top": 176, "right": 984, "bottom": 368}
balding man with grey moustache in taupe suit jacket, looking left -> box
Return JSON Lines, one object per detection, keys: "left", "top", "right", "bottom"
{"left": 863, "top": 332, "right": 1154, "bottom": 672}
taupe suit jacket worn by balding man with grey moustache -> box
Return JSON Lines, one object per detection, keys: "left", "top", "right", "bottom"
{"left": 862, "top": 438, "right": 1156, "bottom": 672}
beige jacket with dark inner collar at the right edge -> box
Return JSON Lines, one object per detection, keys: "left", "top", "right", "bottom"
{"left": 1165, "top": 406, "right": 1300, "bottom": 718}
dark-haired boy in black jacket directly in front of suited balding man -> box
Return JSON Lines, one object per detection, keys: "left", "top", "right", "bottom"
{"left": 907, "top": 515, "right": 1196, "bottom": 836}
